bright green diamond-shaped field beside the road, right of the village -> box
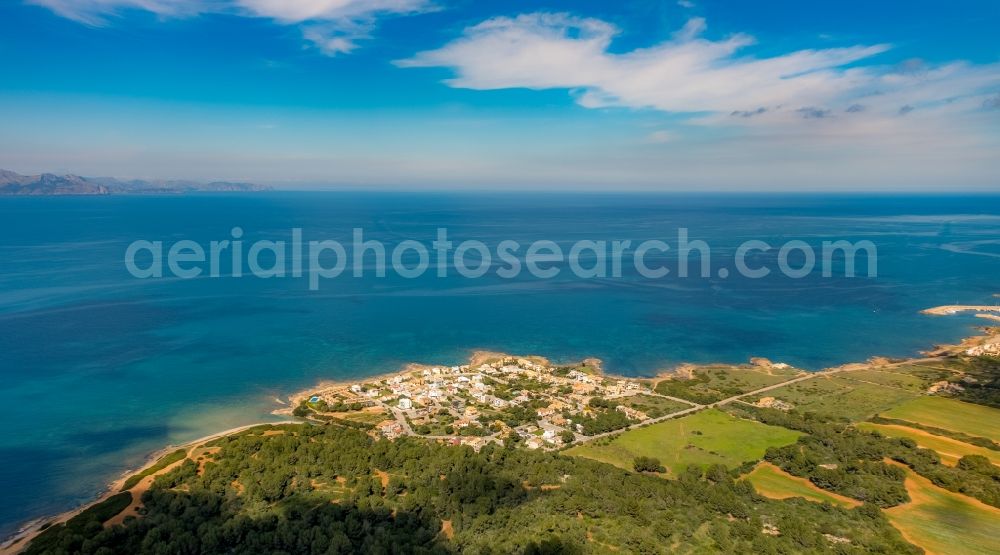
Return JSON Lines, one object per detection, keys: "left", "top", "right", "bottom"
{"left": 566, "top": 409, "right": 801, "bottom": 475}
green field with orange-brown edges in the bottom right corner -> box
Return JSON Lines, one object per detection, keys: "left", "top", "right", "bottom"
{"left": 884, "top": 462, "right": 1000, "bottom": 554}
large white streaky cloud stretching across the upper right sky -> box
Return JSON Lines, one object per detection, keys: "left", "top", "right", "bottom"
{"left": 397, "top": 13, "right": 1000, "bottom": 125}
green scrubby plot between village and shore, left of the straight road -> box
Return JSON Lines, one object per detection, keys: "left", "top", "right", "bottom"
{"left": 655, "top": 366, "right": 800, "bottom": 404}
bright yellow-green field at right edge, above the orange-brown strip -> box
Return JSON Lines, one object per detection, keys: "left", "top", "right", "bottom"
{"left": 882, "top": 396, "right": 1000, "bottom": 441}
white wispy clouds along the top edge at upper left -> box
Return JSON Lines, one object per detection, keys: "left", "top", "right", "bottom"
{"left": 28, "top": 0, "right": 430, "bottom": 56}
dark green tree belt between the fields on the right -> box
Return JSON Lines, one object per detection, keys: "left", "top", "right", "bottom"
{"left": 729, "top": 407, "right": 1000, "bottom": 507}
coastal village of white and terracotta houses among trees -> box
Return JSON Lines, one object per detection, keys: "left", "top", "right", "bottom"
{"left": 295, "top": 356, "right": 680, "bottom": 450}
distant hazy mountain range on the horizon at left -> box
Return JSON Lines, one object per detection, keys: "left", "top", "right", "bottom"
{"left": 0, "top": 170, "right": 270, "bottom": 196}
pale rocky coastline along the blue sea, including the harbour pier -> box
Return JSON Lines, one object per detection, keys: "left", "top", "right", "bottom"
{"left": 0, "top": 306, "right": 1000, "bottom": 555}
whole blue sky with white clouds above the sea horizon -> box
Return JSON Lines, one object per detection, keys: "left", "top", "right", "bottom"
{"left": 0, "top": 0, "right": 1000, "bottom": 191}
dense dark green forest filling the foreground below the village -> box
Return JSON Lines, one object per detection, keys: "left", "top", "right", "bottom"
{"left": 29, "top": 425, "right": 920, "bottom": 554}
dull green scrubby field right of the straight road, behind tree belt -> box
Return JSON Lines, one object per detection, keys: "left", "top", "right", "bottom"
{"left": 747, "top": 372, "right": 919, "bottom": 421}
